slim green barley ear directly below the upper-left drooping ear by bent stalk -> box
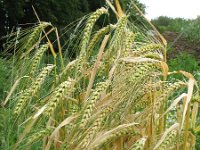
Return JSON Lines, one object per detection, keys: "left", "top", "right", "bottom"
{"left": 30, "top": 44, "right": 49, "bottom": 75}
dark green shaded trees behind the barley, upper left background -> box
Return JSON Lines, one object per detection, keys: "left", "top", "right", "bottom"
{"left": 0, "top": 0, "right": 144, "bottom": 51}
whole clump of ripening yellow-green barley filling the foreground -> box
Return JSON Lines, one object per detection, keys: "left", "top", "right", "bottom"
{"left": 0, "top": 1, "right": 199, "bottom": 150}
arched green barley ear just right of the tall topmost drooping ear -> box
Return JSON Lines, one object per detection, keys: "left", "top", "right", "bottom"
{"left": 87, "top": 24, "right": 116, "bottom": 53}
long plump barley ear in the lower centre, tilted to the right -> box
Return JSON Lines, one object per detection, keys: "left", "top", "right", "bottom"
{"left": 80, "top": 81, "right": 110, "bottom": 128}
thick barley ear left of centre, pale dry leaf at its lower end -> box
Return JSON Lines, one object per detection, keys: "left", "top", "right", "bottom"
{"left": 44, "top": 78, "right": 75, "bottom": 116}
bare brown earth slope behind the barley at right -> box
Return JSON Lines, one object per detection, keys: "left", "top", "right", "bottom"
{"left": 163, "top": 31, "right": 200, "bottom": 60}
